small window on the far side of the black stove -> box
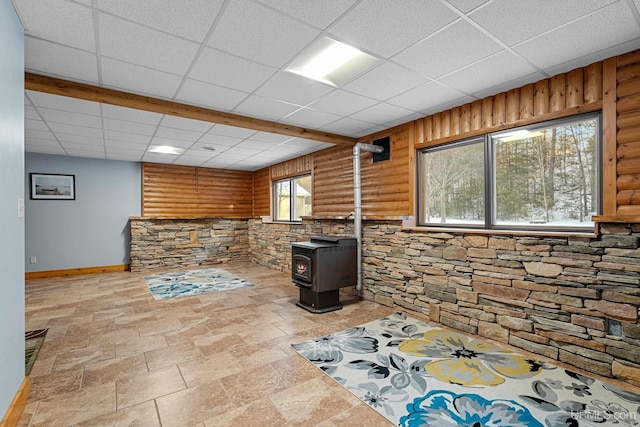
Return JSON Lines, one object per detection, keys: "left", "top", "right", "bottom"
{"left": 273, "top": 175, "right": 311, "bottom": 221}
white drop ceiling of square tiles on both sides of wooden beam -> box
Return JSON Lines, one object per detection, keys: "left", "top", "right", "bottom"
{"left": 12, "top": 0, "right": 640, "bottom": 170}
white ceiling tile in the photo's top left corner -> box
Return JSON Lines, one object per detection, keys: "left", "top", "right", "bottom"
{"left": 14, "top": 0, "right": 95, "bottom": 52}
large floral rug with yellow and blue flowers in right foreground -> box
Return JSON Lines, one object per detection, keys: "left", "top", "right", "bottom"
{"left": 292, "top": 313, "right": 640, "bottom": 427}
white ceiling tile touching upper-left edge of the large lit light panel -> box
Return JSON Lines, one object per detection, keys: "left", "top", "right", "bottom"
{"left": 208, "top": 1, "right": 320, "bottom": 68}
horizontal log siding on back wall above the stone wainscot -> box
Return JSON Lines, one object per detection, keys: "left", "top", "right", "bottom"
{"left": 142, "top": 163, "right": 253, "bottom": 218}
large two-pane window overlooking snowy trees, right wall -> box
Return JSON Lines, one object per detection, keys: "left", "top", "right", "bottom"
{"left": 419, "top": 114, "right": 601, "bottom": 230}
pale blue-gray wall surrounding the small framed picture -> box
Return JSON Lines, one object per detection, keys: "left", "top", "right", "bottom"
{"left": 23, "top": 153, "right": 142, "bottom": 272}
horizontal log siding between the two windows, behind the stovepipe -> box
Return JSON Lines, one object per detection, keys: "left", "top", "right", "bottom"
{"left": 313, "top": 125, "right": 413, "bottom": 217}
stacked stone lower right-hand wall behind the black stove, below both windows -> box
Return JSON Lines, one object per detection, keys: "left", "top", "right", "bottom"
{"left": 249, "top": 220, "right": 640, "bottom": 386}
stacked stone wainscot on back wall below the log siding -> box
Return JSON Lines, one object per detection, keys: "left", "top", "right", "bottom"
{"left": 130, "top": 217, "right": 249, "bottom": 272}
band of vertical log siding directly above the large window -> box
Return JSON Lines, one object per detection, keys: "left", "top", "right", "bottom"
{"left": 415, "top": 62, "right": 602, "bottom": 147}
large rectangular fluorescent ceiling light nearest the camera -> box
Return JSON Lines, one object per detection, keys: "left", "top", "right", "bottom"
{"left": 287, "top": 37, "right": 378, "bottom": 86}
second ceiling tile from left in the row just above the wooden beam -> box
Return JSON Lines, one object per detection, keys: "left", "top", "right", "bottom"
{"left": 102, "top": 58, "right": 182, "bottom": 99}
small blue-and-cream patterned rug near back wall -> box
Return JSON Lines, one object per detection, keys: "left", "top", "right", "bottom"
{"left": 144, "top": 268, "right": 253, "bottom": 300}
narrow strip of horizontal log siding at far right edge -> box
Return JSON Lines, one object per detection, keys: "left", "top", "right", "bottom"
{"left": 616, "top": 50, "right": 640, "bottom": 216}
